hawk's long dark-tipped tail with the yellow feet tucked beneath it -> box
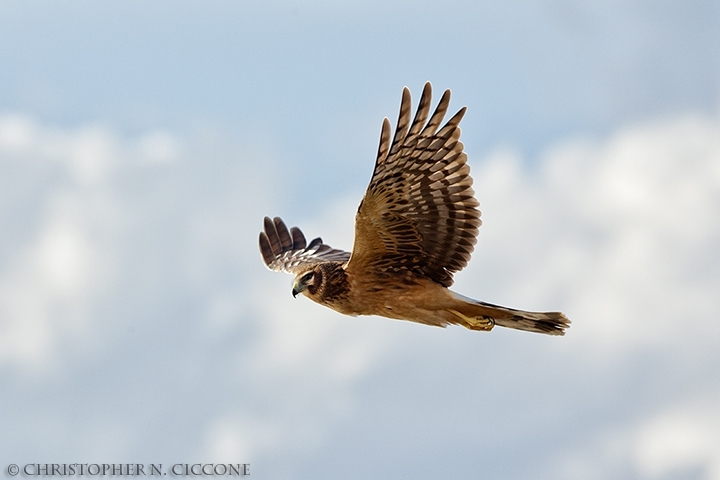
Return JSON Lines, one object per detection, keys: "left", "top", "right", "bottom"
{"left": 449, "top": 292, "right": 570, "bottom": 335}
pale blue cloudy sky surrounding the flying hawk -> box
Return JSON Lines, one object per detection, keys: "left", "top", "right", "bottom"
{"left": 0, "top": 0, "right": 720, "bottom": 479}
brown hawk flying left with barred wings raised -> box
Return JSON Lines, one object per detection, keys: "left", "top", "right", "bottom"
{"left": 260, "top": 82, "right": 570, "bottom": 335}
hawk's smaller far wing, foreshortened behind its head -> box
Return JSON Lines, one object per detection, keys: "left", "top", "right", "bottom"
{"left": 260, "top": 217, "right": 350, "bottom": 275}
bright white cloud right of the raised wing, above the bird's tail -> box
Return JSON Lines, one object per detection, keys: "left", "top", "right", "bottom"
{"left": 466, "top": 111, "right": 720, "bottom": 354}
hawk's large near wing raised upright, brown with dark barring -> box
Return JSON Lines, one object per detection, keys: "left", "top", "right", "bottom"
{"left": 346, "top": 82, "right": 482, "bottom": 287}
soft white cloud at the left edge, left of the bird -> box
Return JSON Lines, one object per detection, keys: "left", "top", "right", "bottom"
{"left": 0, "top": 115, "right": 273, "bottom": 374}
